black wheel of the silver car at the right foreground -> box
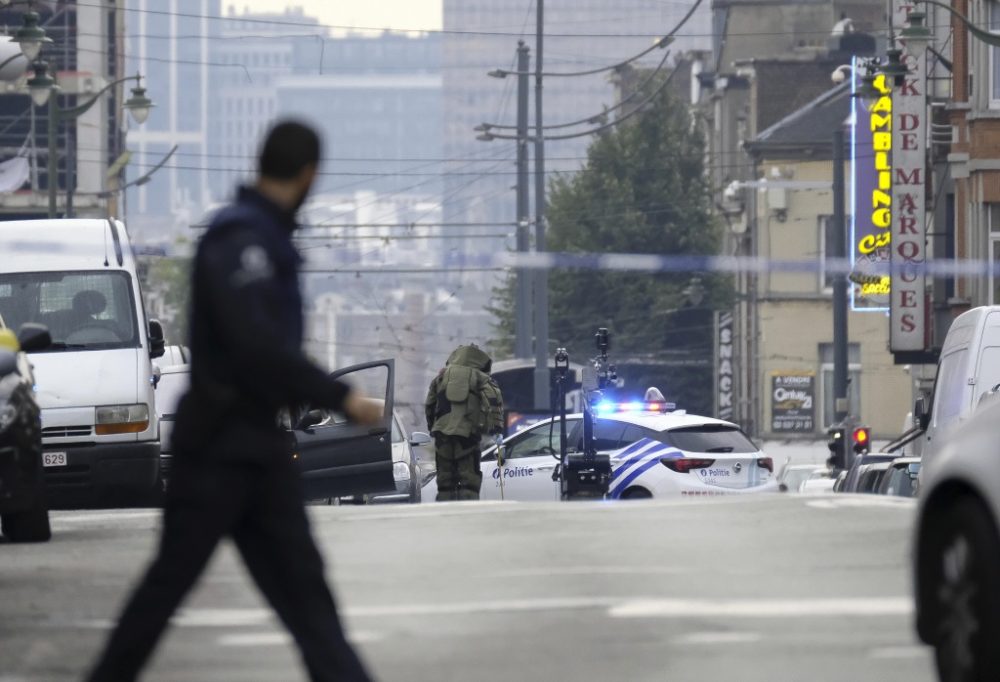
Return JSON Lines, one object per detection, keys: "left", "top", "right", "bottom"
{"left": 919, "top": 497, "right": 1000, "bottom": 682}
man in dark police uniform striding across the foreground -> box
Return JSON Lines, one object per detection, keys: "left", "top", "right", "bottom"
{"left": 89, "top": 121, "right": 384, "bottom": 682}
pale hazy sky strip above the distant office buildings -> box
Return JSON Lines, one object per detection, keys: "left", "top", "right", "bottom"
{"left": 238, "top": 0, "right": 441, "bottom": 29}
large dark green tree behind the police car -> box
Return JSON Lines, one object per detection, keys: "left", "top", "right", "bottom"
{"left": 494, "top": 75, "right": 731, "bottom": 412}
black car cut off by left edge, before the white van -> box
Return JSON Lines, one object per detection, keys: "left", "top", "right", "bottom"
{"left": 0, "top": 321, "right": 52, "bottom": 542}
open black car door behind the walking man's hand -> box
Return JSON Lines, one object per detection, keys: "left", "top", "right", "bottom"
{"left": 292, "top": 359, "right": 396, "bottom": 500}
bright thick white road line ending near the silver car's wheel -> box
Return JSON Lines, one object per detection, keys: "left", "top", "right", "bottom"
{"left": 608, "top": 597, "right": 913, "bottom": 618}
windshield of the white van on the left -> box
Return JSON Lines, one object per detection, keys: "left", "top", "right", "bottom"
{"left": 0, "top": 270, "right": 139, "bottom": 352}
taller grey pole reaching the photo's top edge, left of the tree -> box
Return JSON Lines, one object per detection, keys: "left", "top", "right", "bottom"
{"left": 534, "top": 0, "right": 551, "bottom": 410}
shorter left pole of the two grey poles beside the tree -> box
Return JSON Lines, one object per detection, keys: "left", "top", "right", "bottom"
{"left": 514, "top": 40, "right": 531, "bottom": 358}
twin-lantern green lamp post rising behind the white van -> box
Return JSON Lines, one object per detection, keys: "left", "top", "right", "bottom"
{"left": 27, "top": 62, "right": 155, "bottom": 218}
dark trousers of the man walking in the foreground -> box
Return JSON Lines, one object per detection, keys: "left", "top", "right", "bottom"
{"left": 89, "top": 446, "right": 369, "bottom": 682}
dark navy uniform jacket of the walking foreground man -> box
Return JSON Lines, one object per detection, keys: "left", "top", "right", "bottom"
{"left": 174, "top": 187, "right": 348, "bottom": 460}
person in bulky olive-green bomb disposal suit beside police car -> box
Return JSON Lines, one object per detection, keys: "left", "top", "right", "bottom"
{"left": 424, "top": 344, "right": 503, "bottom": 502}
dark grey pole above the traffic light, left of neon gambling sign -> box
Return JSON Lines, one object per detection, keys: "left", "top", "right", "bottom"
{"left": 831, "top": 128, "right": 850, "bottom": 430}
